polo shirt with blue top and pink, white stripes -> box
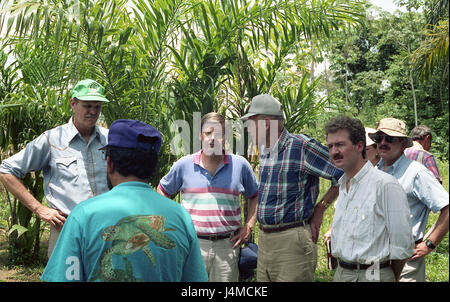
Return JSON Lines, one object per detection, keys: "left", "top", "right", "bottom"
{"left": 158, "top": 150, "right": 258, "bottom": 235}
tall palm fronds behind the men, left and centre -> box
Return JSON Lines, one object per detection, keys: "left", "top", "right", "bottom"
{"left": 0, "top": 0, "right": 363, "bottom": 264}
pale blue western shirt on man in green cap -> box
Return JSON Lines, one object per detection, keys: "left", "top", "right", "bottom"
{"left": 0, "top": 117, "right": 108, "bottom": 214}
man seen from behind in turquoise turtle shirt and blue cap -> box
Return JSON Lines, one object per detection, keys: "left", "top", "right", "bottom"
{"left": 41, "top": 120, "right": 207, "bottom": 282}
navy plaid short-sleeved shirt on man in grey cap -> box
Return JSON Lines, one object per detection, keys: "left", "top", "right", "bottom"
{"left": 257, "top": 129, "right": 343, "bottom": 225}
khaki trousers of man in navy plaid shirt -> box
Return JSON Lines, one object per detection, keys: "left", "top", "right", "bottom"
{"left": 256, "top": 225, "right": 317, "bottom": 282}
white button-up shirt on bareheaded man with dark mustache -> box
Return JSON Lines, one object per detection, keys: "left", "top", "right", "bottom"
{"left": 331, "top": 161, "right": 414, "bottom": 264}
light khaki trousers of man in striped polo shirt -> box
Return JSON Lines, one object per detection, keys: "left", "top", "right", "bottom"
{"left": 198, "top": 238, "right": 240, "bottom": 282}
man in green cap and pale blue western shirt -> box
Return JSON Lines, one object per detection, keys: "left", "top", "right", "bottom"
{"left": 0, "top": 79, "right": 108, "bottom": 257}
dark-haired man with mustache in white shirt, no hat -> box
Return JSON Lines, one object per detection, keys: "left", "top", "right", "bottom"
{"left": 325, "top": 116, "right": 414, "bottom": 282}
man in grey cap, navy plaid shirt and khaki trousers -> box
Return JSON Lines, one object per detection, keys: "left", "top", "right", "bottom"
{"left": 241, "top": 94, "right": 343, "bottom": 282}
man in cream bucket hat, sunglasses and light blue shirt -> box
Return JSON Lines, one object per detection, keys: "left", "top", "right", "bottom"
{"left": 369, "top": 118, "right": 449, "bottom": 282}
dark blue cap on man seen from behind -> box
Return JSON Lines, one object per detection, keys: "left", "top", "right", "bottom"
{"left": 99, "top": 119, "right": 162, "bottom": 153}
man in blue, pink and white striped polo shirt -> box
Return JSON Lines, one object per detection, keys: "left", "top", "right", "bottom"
{"left": 157, "top": 112, "right": 258, "bottom": 282}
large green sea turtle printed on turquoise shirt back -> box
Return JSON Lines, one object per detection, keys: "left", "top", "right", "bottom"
{"left": 100, "top": 215, "right": 176, "bottom": 280}
